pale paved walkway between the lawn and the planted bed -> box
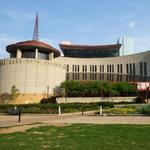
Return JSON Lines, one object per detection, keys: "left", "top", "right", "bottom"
{"left": 0, "top": 114, "right": 150, "bottom": 127}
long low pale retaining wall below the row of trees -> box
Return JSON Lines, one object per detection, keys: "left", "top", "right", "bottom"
{"left": 57, "top": 97, "right": 136, "bottom": 103}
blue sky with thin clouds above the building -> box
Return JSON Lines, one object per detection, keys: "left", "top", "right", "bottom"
{"left": 0, "top": 0, "right": 150, "bottom": 58}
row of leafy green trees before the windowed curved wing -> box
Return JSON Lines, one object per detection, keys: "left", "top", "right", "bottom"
{"left": 60, "top": 81, "right": 137, "bottom": 97}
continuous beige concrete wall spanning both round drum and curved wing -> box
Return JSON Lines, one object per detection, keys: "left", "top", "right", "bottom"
{"left": 0, "top": 51, "right": 150, "bottom": 103}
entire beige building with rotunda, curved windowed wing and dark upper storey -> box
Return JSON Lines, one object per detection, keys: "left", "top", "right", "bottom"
{"left": 0, "top": 40, "right": 150, "bottom": 104}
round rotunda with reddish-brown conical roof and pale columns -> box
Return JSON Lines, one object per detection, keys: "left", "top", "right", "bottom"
{"left": 6, "top": 40, "right": 60, "bottom": 60}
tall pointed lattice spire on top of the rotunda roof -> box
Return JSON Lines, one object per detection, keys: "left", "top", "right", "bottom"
{"left": 33, "top": 13, "right": 39, "bottom": 41}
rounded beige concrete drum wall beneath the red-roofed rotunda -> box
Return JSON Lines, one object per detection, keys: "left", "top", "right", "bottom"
{"left": 0, "top": 58, "right": 66, "bottom": 103}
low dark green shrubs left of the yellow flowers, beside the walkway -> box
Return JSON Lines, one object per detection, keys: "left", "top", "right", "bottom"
{"left": 0, "top": 100, "right": 114, "bottom": 114}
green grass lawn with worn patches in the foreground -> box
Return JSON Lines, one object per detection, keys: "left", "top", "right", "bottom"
{"left": 0, "top": 124, "right": 150, "bottom": 150}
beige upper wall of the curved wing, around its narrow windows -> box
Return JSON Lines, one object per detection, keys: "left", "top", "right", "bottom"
{"left": 54, "top": 51, "right": 150, "bottom": 76}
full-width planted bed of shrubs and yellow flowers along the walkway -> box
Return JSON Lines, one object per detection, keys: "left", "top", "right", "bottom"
{"left": 0, "top": 102, "right": 150, "bottom": 115}
